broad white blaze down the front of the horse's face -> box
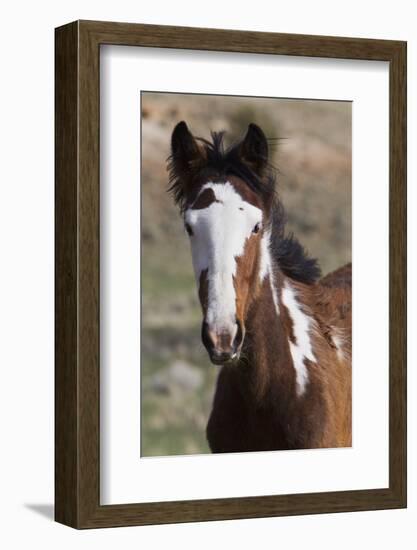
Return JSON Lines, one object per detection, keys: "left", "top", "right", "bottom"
{"left": 184, "top": 182, "right": 262, "bottom": 332}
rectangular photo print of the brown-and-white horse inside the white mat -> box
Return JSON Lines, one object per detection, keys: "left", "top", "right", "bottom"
{"left": 140, "top": 92, "right": 352, "bottom": 457}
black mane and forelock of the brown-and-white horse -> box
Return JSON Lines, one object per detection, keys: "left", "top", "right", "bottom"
{"left": 168, "top": 132, "right": 321, "bottom": 284}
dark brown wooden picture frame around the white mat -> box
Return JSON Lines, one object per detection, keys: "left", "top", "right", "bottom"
{"left": 55, "top": 21, "right": 407, "bottom": 528}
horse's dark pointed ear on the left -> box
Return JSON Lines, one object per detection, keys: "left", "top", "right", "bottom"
{"left": 171, "top": 120, "right": 204, "bottom": 177}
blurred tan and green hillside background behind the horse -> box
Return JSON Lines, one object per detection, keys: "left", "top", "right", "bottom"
{"left": 141, "top": 92, "right": 352, "bottom": 456}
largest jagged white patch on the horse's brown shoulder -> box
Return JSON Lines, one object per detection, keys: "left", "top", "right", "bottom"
{"left": 282, "top": 281, "right": 316, "bottom": 396}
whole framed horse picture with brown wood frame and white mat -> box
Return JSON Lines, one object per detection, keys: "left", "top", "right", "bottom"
{"left": 55, "top": 21, "right": 406, "bottom": 528}
